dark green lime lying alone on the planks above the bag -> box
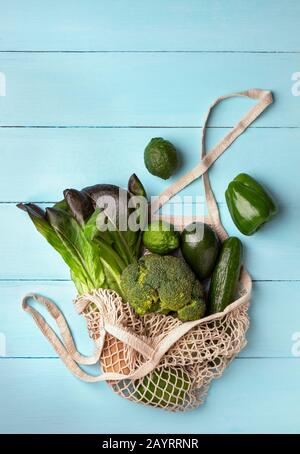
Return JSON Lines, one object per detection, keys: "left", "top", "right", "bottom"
{"left": 144, "top": 137, "right": 178, "bottom": 180}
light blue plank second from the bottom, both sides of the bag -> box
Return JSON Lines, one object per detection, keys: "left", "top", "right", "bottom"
{"left": 0, "top": 282, "right": 300, "bottom": 358}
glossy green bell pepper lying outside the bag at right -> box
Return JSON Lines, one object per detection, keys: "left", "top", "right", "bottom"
{"left": 225, "top": 173, "right": 277, "bottom": 235}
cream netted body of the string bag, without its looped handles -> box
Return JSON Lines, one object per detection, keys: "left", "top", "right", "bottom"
{"left": 75, "top": 275, "right": 251, "bottom": 411}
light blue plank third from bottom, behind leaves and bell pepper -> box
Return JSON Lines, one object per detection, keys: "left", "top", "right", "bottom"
{"left": 0, "top": 204, "right": 300, "bottom": 280}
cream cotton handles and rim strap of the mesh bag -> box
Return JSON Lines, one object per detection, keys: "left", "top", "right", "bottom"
{"left": 22, "top": 89, "right": 273, "bottom": 383}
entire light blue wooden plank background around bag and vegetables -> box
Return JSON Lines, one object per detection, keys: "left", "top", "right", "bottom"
{"left": 0, "top": 0, "right": 300, "bottom": 433}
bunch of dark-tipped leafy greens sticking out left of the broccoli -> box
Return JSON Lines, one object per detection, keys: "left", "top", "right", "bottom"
{"left": 17, "top": 172, "right": 146, "bottom": 296}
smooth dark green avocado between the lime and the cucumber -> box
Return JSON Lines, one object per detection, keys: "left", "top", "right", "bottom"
{"left": 181, "top": 222, "right": 220, "bottom": 280}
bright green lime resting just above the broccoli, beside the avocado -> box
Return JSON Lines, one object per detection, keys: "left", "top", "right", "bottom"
{"left": 143, "top": 221, "right": 180, "bottom": 254}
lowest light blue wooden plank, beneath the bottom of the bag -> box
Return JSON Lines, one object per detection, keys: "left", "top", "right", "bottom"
{"left": 0, "top": 359, "right": 300, "bottom": 434}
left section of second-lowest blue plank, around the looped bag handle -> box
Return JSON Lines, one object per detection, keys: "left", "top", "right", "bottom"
{"left": 0, "top": 282, "right": 94, "bottom": 357}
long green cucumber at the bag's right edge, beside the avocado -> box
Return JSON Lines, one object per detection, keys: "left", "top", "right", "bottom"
{"left": 208, "top": 236, "right": 243, "bottom": 314}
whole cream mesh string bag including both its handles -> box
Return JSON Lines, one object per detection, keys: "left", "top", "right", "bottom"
{"left": 23, "top": 89, "right": 272, "bottom": 412}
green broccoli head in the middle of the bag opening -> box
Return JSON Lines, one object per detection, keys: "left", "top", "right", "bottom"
{"left": 121, "top": 254, "right": 205, "bottom": 321}
